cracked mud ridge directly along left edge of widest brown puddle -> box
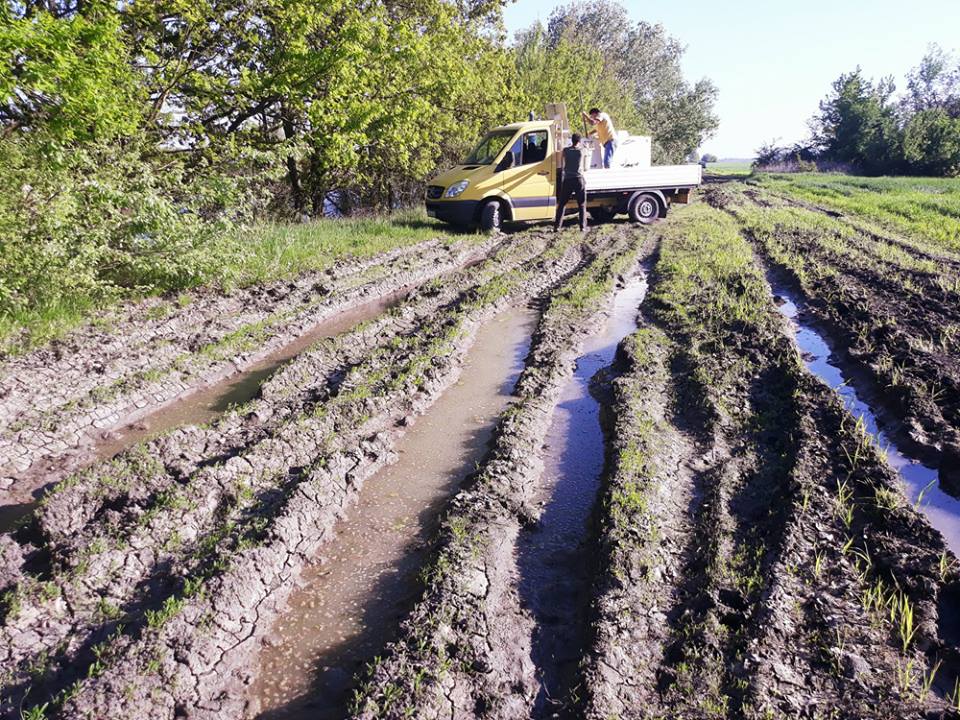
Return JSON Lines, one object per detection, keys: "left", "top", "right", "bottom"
{"left": 3, "top": 231, "right": 580, "bottom": 717}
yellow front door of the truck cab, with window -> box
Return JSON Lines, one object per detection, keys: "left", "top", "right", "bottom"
{"left": 500, "top": 130, "right": 557, "bottom": 220}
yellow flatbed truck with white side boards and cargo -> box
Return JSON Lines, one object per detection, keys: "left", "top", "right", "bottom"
{"left": 425, "top": 113, "right": 702, "bottom": 231}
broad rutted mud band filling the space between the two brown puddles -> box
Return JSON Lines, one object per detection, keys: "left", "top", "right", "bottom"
{"left": 0, "top": 228, "right": 583, "bottom": 717}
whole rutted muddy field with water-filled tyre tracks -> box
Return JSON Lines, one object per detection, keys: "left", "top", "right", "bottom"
{"left": 0, "top": 183, "right": 960, "bottom": 720}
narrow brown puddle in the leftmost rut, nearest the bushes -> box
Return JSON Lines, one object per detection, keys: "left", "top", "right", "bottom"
{"left": 0, "top": 287, "right": 412, "bottom": 532}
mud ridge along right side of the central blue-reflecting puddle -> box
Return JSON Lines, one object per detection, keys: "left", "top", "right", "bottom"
{"left": 582, "top": 327, "right": 701, "bottom": 719}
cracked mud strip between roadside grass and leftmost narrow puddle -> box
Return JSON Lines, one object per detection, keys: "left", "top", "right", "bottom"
{"left": 0, "top": 233, "right": 502, "bottom": 501}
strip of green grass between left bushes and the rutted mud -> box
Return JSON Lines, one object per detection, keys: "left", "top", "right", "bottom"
{"left": 0, "top": 211, "right": 458, "bottom": 354}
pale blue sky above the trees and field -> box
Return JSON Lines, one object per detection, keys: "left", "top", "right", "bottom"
{"left": 504, "top": 0, "right": 960, "bottom": 157}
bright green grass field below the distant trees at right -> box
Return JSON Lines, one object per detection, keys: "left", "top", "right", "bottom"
{"left": 756, "top": 173, "right": 960, "bottom": 252}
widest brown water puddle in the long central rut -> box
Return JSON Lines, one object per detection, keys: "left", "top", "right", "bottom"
{"left": 251, "top": 309, "right": 535, "bottom": 719}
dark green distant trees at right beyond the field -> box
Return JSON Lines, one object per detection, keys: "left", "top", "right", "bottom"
{"left": 755, "top": 45, "right": 960, "bottom": 177}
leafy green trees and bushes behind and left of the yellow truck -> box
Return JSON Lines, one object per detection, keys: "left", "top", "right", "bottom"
{"left": 0, "top": 0, "right": 716, "bottom": 330}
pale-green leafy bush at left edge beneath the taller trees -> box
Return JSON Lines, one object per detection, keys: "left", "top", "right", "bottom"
{"left": 0, "top": 137, "right": 278, "bottom": 350}
